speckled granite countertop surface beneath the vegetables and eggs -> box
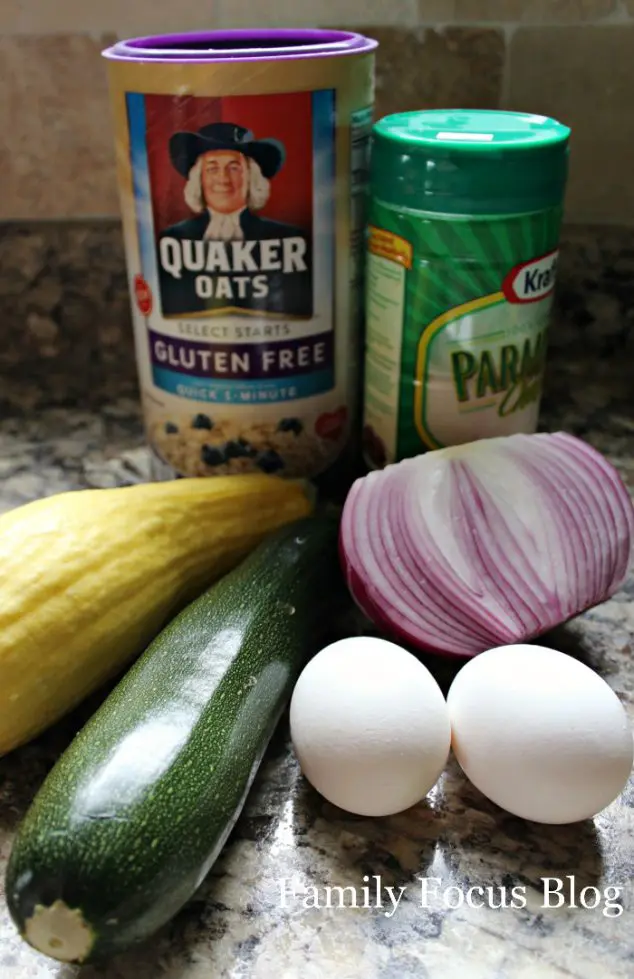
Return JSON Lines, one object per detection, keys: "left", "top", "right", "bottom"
{"left": 0, "top": 358, "right": 634, "bottom": 979}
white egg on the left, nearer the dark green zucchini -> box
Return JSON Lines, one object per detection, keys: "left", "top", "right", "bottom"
{"left": 290, "top": 636, "right": 451, "bottom": 816}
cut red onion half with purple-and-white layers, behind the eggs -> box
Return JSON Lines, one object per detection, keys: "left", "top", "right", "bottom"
{"left": 341, "top": 432, "right": 634, "bottom": 657}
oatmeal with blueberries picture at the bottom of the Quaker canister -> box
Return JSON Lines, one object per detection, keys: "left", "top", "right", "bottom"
{"left": 150, "top": 412, "right": 343, "bottom": 478}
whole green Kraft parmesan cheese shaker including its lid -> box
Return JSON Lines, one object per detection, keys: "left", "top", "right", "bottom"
{"left": 363, "top": 110, "right": 570, "bottom": 468}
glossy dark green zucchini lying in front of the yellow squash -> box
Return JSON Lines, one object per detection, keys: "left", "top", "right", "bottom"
{"left": 6, "top": 515, "right": 347, "bottom": 963}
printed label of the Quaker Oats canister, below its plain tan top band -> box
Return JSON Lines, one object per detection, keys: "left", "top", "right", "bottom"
{"left": 116, "top": 88, "right": 371, "bottom": 478}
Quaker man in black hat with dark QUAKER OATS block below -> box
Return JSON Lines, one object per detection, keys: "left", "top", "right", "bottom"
{"left": 159, "top": 122, "right": 312, "bottom": 315}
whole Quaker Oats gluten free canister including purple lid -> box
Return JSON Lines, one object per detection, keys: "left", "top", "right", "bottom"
{"left": 104, "top": 30, "right": 377, "bottom": 479}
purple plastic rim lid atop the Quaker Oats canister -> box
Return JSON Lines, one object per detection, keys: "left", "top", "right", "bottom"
{"left": 103, "top": 29, "right": 378, "bottom": 64}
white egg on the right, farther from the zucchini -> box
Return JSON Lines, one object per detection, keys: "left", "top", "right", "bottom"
{"left": 447, "top": 644, "right": 634, "bottom": 823}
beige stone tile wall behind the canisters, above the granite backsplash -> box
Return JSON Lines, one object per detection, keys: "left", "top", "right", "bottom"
{"left": 0, "top": 0, "right": 634, "bottom": 225}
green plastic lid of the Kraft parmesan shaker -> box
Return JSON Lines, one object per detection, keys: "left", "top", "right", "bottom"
{"left": 371, "top": 109, "right": 570, "bottom": 214}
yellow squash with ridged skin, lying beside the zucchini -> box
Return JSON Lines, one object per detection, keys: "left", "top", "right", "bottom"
{"left": 0, "top": 475, "right": 312, "bottom": 755}
